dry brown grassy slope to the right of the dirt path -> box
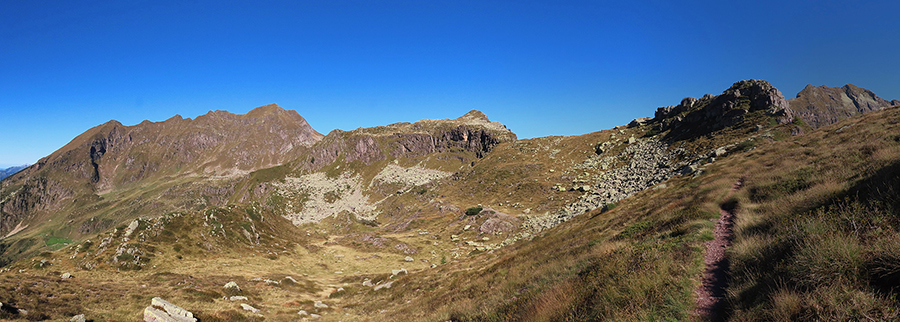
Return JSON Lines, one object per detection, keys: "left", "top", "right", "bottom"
{"left": 728, "top": 109, "right": 900, "bottom": 321}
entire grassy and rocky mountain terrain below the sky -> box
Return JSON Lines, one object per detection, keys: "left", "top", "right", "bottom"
{"left": 0, "top": 80, "right": 900, "bottom": 321}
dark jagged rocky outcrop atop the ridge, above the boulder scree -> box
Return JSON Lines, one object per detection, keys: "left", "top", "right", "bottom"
{"left": 653, "top": 79, "right": 793, "bottom": 139}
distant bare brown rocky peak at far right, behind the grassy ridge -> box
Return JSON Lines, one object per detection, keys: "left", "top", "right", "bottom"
{"left": 788, "top": 84, "right": 900, "bottom": 129}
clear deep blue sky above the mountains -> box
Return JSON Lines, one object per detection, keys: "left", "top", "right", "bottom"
{"left": 0, "top": 0, "right": 900, "bottom": 165}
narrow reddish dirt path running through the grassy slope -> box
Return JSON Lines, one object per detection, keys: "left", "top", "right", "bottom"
{"left": 694, "top": 178, "right": 744, "bottom": 321}
